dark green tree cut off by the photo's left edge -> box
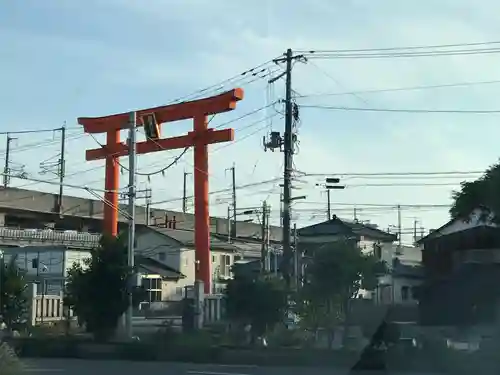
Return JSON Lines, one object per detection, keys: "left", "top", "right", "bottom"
{"left": 0, "top": 256, "right": 28, "bottom": 329}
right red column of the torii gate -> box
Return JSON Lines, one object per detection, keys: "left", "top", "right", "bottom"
{"left": 194, "top": 115, "right": 212, "bottom": 294}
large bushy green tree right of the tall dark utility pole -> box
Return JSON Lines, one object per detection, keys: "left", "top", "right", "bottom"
{"left": 298, "top": 240, "right": 386, "bottom": 345}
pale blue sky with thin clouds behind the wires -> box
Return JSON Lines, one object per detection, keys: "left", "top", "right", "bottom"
{"left": 0, "top": 0, "right": 500, "bottom": 244}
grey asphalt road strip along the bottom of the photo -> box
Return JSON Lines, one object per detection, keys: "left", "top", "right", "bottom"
{"left": 19, "top": 359, "right": 429, "bottom": 375}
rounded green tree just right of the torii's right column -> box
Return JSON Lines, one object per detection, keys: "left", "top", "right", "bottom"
{"left": 225, "top": 273, "right": 287, "bottom": 339}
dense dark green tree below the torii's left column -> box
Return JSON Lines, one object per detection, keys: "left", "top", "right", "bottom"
{"left": 64, "top": 236, "right": 142, "bottom": 341}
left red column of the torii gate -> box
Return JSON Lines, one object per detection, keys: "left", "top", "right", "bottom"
{"left": 103, "top": 130, "right": 120, "bottom": 236}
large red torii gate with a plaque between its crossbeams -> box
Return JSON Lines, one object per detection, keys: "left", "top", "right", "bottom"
{"left": 78, "top": 88, "right": 243, "bottom": 293}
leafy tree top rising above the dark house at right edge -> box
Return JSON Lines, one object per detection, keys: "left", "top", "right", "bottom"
{"left": 450, "top": 162, "right": 500, "bottom": 224}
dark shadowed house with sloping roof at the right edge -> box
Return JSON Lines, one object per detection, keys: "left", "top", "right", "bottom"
{"left": 418, "top": 210, "right": 500, "bottom": 326}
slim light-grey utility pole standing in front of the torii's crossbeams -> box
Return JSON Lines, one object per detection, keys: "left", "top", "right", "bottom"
{"left": 126, "top": 112, "right": 137, "bottom": 339}
